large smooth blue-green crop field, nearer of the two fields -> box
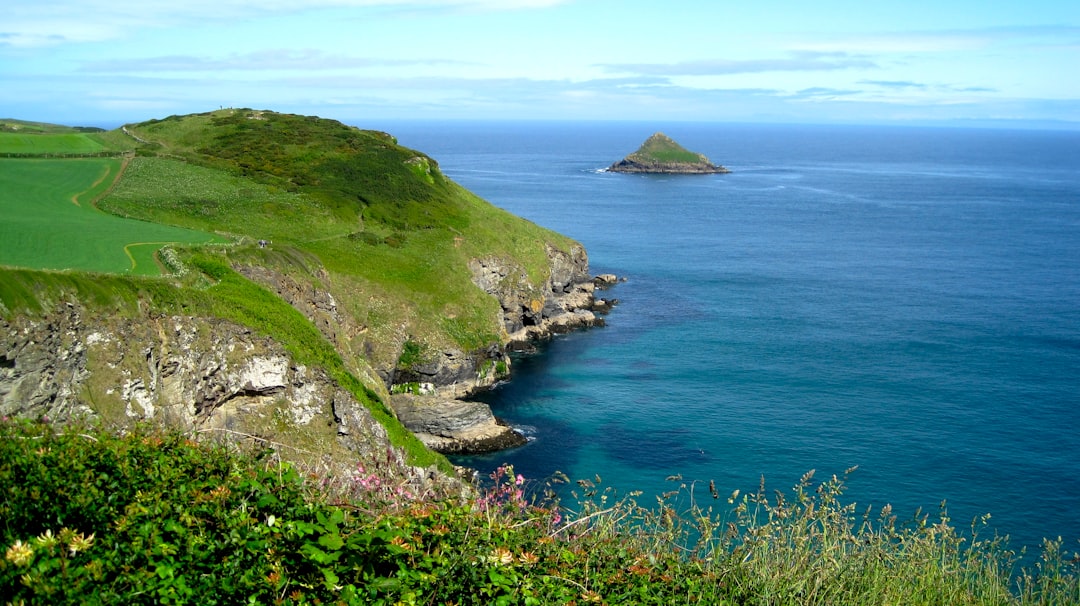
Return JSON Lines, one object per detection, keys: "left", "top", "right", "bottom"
{"left": 0, "top": 159, "right": 225, "bottom": 275}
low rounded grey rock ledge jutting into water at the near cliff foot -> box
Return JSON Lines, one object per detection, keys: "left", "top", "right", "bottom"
{"left": 391, "top": 394, "right": 525, "bottom": 454}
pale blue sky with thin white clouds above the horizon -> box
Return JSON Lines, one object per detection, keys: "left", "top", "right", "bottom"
{"left": 6, "top": 0, "right": 1080, "bottom": 129}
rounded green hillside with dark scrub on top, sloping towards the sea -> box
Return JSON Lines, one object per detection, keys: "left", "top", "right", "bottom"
{"left": 100, "top": 110, "right": 572, "bottom": 349}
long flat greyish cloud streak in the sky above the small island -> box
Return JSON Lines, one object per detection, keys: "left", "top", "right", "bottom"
{"left": 597, "top": 52, "right": 877, "bottom": 76}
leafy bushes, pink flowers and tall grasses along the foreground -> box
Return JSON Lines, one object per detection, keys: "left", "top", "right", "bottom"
{"left": 0, "top": 422, "right": 1080, "bottom": 604}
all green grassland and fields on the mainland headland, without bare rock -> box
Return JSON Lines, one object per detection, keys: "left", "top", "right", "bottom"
{"left": 0, "top": 110, "right": 572, "bottom": 469}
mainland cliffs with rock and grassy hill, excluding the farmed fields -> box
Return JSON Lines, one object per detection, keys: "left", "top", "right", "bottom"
{"left": 0, "top": 110, "right": 622, "bottom": 477}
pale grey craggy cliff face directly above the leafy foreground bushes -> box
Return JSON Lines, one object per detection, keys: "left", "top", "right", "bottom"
{"left": 0, "top": 304, "right": 446, "bottom": 494}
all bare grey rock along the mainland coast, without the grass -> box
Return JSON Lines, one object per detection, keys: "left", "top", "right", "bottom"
{"left": 0, "top": 241, "right": 617, "bottom": 462}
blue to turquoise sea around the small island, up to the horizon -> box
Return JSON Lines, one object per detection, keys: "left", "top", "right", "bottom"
{"left": 380, "top": 122, "right": 1080, "bottom": 549}
